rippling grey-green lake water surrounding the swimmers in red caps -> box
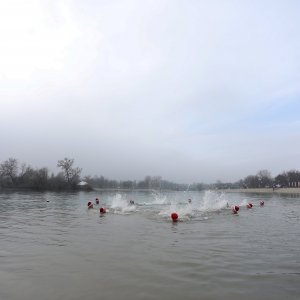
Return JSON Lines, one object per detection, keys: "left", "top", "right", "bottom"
{"left": 0, "top": 191, "right": 300, "bottom": 300}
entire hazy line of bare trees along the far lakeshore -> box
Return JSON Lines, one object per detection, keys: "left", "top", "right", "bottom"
{"left": 0, "top": 158, "right": 300, "bottom": 191}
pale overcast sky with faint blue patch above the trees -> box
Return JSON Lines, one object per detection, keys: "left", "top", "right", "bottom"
{"left": 0, "top": 0, "right": 300, "bottom": 183}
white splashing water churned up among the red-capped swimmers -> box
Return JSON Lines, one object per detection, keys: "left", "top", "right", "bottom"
{"left": 96, "top": 191, "right": 239, "bottom": 221}
